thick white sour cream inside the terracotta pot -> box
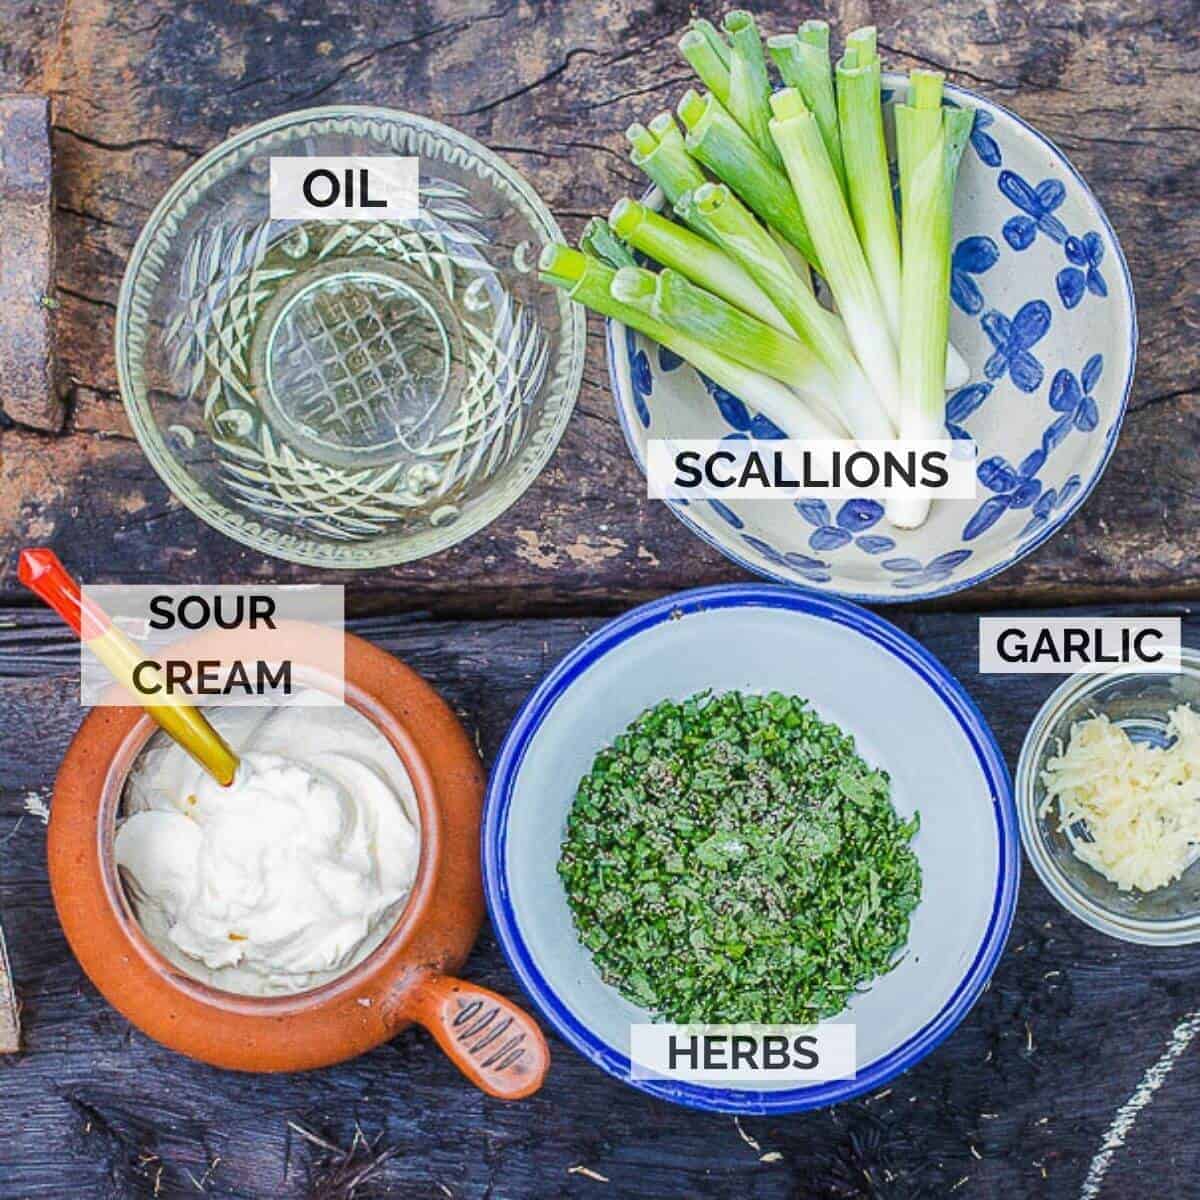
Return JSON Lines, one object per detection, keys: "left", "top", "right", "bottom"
{"left": 115, "top": 692, "right": 420, "bottom": 996}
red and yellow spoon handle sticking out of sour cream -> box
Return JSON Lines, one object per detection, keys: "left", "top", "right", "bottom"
{"left": 17, "top": 547, "right": 238, "bottom": 787}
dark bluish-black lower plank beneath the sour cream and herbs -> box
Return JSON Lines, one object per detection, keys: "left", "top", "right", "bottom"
{"left": 0, "top": 610, "right": 1200, "bottom": 1200}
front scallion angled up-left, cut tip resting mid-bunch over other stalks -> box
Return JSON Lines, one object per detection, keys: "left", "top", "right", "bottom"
{"left": 679, "top": 184, "right": 895, "bottom": 440}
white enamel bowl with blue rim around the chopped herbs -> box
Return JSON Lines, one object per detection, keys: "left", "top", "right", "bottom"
{"left": 484, "top": 584, "right": 1019, "bottom": 1114}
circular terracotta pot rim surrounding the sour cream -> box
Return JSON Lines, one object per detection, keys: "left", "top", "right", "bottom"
{"left": 96, "top": 667, "right": 442, "bottom": 1019}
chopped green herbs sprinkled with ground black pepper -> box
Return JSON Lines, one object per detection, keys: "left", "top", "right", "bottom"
{"left": 558, "top": 691, "right": 920, "bottom": 1024}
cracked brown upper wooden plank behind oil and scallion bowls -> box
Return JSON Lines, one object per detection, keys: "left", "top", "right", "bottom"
{"left": 0, "top": 0, "right": 1200, "bottom": 613}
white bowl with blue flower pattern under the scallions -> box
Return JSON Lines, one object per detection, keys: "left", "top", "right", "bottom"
{"left": 608, "top": 76, "right": 1138, "bottom": 604}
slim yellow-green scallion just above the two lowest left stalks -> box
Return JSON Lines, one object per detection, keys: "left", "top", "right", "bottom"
{"left": 609, "top": 199, "right": 792, "bottom": 332}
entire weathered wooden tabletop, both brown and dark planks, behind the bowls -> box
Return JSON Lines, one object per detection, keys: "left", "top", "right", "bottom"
{"left": 0, "top": 0, "right": 1200, "bottom": 1200}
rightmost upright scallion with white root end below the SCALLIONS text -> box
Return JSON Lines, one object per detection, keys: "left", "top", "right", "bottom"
{"left": 888, "top": 71, "right": 974, "bottom": 529}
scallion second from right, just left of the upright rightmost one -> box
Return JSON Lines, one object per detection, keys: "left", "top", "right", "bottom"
{"left": 838, "top": 26, "right": 971, "bottom": 388}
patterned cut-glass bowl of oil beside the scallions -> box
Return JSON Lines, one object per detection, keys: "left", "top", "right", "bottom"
{"left": 116, "top": 106, "right": 584, "bottom": 568}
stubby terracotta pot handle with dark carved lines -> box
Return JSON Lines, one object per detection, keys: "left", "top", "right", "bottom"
{"left": 404, "top": 974, "right": 550, "bottom": 1100}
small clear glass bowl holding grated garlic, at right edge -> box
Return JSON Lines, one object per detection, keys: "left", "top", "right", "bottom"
{"left": 1016, "top": 648, "right": 1200, "bottom": 946}
